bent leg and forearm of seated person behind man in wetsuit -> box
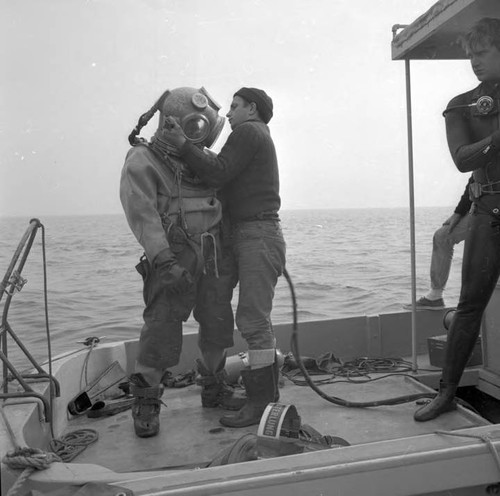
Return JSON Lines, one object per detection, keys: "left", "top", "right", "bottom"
{"left": 404, "top": 176, "right": 473, "bottom": 310}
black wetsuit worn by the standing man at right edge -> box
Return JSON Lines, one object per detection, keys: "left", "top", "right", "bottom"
{"left": 442, "top": 83, "right": 500, "bottom": 385}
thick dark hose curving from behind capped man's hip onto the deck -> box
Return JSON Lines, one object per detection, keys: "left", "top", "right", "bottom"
{"left": 283, "top": 269, "right": 436, "bottom": 408}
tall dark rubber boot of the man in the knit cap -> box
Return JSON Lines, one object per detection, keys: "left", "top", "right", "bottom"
{"left": 219, "top": 362, "right": 279, "bottom": 427}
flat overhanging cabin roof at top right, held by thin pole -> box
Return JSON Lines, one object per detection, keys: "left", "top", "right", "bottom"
{"left": 391, "top": 0, "right": 500, "bottom": 60}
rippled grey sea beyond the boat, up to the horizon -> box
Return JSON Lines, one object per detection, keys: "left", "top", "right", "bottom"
{"left": 0, "top": 207, "right": 463, "bottom": 362}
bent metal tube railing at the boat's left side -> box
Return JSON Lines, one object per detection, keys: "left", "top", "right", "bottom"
{"left": 0, "top": 219, "right": 60, "bottom": 422}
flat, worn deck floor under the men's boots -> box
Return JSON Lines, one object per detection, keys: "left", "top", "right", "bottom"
{"left": 67, "top": 368, "right": 489, "bottom": 472}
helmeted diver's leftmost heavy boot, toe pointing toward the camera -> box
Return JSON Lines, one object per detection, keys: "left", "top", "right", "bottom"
{"left": 130, "top": 373, "right": 163, "bottom": 437}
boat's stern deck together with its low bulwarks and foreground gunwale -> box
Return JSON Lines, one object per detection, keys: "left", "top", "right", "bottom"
{"left": 0, "top": 312, "right": 500, "bottom": 496}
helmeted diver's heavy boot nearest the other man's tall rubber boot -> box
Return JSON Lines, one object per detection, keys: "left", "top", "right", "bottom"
{"left": 196, "top": 357, "right": 246, "bottom": 410}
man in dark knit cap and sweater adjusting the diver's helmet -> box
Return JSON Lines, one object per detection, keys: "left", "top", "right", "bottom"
{"left": 167, "top": 88, "right": 286, "bottom": 427}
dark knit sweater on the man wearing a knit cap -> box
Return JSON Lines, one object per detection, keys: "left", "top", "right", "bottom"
{"left": 180, "top": 120, "right": 281, "bottom": 222}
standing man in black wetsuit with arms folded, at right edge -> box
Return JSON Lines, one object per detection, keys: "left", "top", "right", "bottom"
{"left": 414, "top": 18, "right": 500, "bottom": 422}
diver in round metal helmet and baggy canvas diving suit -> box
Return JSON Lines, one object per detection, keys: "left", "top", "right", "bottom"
{"left": 120, "top": 87, "right": 241, "bottom": 437}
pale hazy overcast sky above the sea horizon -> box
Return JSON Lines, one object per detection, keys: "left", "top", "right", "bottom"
{"left": 0, "top": 0, "right": 477, "bottom": 217}
